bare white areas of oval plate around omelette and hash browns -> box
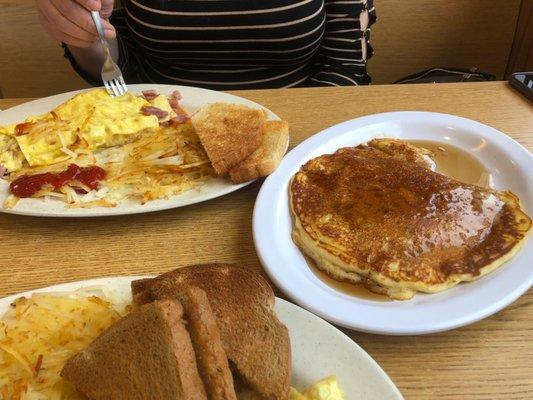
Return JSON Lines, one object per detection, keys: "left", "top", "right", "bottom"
{"left": 0, "top": 84, "right": 282, "bottom": 217}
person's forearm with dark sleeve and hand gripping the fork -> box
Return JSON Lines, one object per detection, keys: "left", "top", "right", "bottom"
{"left": 36, "top": 0, "right": 119, "bottom": 81}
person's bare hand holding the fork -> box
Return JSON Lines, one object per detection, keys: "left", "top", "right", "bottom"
{"left": 36, "top": 0, "right": 116, "bottom": 48}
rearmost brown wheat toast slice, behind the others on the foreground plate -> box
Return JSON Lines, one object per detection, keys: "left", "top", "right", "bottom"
{"left": 132, "top": 264, "right": 291, "bottom": 400}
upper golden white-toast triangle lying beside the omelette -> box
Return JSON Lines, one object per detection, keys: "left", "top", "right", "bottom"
{"left": 192, "top": 103, "right": 266, "bottom": 176}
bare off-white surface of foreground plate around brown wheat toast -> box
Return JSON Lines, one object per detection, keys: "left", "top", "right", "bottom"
{"left": 0, "top": 276, "right": 402, "bottom": 400}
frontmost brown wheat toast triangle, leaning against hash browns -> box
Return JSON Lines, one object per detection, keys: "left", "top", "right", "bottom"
{"left": 61, "top": 300, "right": 207, "bottom": 400}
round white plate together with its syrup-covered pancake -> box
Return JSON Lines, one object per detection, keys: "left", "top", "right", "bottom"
{"left": 253, "top": 112, "right": 533, "bottom": 335}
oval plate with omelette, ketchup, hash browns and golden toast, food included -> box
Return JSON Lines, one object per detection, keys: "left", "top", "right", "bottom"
{"left": 0, "top": 85, "right": 289, "bottom": 217}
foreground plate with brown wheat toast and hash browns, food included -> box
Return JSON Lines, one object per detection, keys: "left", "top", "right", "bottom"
{"left": 0, "top": 264, "right": 402, "bottom": 400}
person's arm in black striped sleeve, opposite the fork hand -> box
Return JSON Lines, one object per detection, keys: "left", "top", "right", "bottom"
{"left": 309, "top": 0, "right": 375, "bottom": 86}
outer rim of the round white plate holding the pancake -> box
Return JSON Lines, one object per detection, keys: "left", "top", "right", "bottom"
{"left": 252, "top": 111, "right": 533, "bottom": 336}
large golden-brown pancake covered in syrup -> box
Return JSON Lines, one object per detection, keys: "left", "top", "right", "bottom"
{"left": 289, "top": 140, "right": 531, "bottom": 300}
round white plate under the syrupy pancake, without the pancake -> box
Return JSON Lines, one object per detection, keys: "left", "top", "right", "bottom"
{"left": 253, "top": 112, "right": 533, "bottom": 335}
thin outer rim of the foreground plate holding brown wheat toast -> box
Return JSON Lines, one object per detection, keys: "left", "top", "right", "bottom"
{"left": 0, "top": 275, "right": 403, "bottom": 400}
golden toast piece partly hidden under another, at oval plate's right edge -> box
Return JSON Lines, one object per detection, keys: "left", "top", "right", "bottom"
{"left": 229, "top": 121, "right": 289, "bottom": 183}
